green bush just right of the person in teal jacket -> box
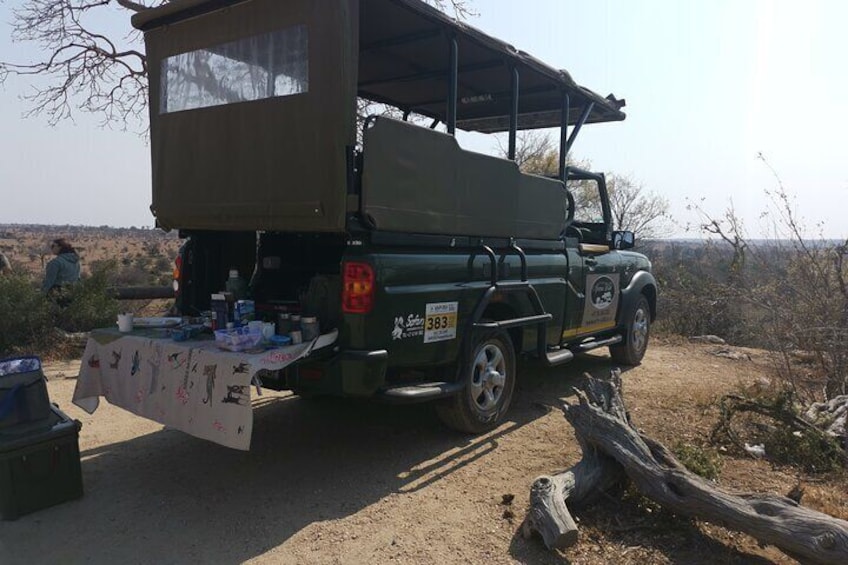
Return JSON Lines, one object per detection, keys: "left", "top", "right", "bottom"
{"left": 56, "top": 262, "right": 121, "bottom": 332}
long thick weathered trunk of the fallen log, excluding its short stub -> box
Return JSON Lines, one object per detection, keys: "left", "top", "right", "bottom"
{"left": 533, "top": 372, "right": 848, "bottom": 564}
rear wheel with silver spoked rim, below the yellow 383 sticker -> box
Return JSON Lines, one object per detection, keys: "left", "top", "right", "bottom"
{"left": 436, "top": 330, "right": 515, "bottom": 434}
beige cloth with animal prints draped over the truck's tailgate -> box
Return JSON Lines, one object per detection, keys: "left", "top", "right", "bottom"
{"left": 73, "top": 330, "right": 338, "bottom": 451}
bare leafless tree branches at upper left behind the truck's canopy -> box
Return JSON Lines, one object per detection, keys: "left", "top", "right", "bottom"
{"left": 0, "top": 0, "right": 474, "bottom": 127}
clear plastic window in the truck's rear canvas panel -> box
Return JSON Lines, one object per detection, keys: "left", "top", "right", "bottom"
{"left": 159, "top": 25, "right": 309, "bottom": 114}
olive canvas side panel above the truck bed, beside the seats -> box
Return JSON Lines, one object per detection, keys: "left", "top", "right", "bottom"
{"left": 362, "top": 118, "right": 567, "bottom": 239}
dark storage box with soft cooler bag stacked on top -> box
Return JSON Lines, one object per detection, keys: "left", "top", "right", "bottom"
{"left": 0, "top": 357, "right": 82, "bottom": 520}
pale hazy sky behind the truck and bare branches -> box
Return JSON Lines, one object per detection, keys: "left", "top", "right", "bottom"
{"left": 0, "top": 0, "right": 848, "bottom": 238}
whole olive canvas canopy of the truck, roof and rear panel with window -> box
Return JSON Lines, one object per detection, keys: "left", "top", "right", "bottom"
{"left": 133, "top": 0, "right": 624, "bottom": 231}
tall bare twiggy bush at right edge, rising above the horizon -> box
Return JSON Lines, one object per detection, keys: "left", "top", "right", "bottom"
{"left": 689, "top": 154, "right": 848, "bottom": 396}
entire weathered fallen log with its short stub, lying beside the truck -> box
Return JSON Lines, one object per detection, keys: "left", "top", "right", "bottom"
{"left": 523, "top": 371, "right": 848, "bottom": 564}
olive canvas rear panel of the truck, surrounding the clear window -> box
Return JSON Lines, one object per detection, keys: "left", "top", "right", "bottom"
{"left": 138, "top": 0, "right": 358, "bottom": 231}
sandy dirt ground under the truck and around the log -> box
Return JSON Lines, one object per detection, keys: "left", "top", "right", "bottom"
{"left": 0, "top": 343, "right": 848, "bottom": 565}
